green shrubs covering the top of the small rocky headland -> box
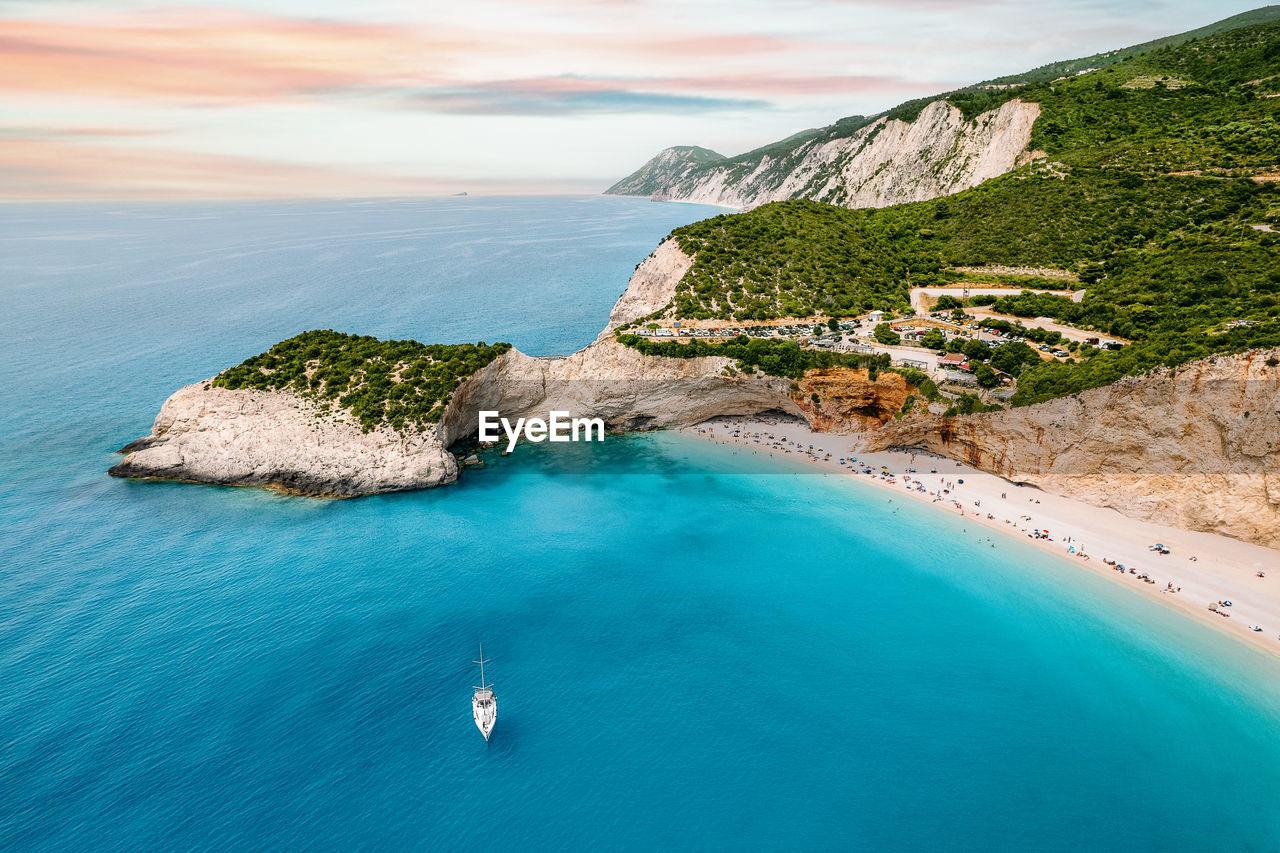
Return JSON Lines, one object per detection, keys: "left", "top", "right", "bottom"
{"left": 212, "top": 329, "right": 511, "bottom": 433}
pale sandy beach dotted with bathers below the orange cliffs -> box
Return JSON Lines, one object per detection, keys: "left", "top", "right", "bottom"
{"left": 685, "top": 416, "right": 1280, "bottom": 656}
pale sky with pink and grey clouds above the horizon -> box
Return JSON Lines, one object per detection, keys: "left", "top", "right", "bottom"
{"left": 0, "top": 0, "right": 1263, "bottom": 200}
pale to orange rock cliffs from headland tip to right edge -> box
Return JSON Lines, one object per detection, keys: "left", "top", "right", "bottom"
{"left": 111, "top": 240, "right": 1280, "bottom": 547}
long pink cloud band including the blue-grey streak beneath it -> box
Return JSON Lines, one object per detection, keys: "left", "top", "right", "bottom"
{"left": 0, "top": 8, "right": 896, "bottom": 106}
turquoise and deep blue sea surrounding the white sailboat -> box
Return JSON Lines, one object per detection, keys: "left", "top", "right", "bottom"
{"left": 0, "top": 197, "right": 1280, "bottom": 850}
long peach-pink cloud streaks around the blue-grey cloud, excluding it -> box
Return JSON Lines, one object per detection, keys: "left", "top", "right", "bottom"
{"left": 0, "top": 9, "right": 895, "bottom": 104}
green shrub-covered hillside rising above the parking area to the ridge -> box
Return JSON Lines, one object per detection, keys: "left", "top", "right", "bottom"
{"left": 614, "top": 24, "right": 1280, "bottom": 403}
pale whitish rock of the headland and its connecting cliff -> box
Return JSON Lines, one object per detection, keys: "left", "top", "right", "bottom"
{"left": 110, "top": 241, "right": 801, "bottom": 497}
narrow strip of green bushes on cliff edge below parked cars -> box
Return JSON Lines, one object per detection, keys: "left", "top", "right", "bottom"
{"left": 618, "top": 334, "right": 890, "bottom": 379}
